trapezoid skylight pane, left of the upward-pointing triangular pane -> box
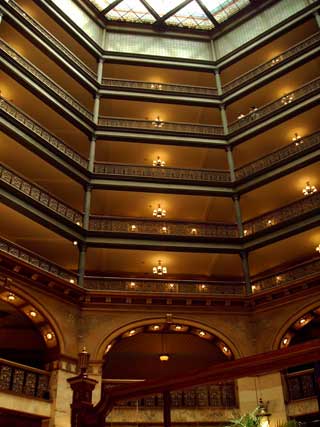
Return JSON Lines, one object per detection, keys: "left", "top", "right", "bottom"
{"left": 106, "top": 0, "right": 156, "bottom": 24}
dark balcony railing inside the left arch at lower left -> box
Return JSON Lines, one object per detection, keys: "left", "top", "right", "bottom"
{"left": 0, "top": 359, "right": 50, "bottom": 400}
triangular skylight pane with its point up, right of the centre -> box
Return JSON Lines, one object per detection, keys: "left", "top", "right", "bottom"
{"left": 165, "top": 1, "right": 214, "bottom": 30}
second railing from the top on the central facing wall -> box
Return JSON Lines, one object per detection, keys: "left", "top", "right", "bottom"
{"left": 98, "top": 116, "right": 224, "bottom": 137}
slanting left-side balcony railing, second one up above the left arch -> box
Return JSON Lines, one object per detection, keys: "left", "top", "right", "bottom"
{"left": 0, "top": 164, "right": 83, "bottom": 226}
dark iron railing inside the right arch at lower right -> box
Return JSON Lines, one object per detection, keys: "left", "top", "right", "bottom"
{"left": 285, "top": 369, "right": 318, "bottom": 401}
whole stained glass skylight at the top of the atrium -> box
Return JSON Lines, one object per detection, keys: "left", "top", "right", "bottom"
{"left": 85, "top": 0, "right": 250, "bottom": 30}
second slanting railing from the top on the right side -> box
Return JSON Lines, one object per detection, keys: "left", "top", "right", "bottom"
{"left": 229, "top": 78, "right": 320, "bottom": 133}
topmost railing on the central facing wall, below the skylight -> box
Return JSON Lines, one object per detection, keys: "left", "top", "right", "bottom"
{"left": 102, "top": 78, "right": 218, "bottom": 97}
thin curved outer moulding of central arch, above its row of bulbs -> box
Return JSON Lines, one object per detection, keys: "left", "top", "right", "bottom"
{"left": 95, "top": 316, "right": 242, "bottom": 360}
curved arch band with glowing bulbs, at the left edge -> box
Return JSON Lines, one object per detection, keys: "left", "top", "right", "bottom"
{"left": 0, "top": 282, "right": 65, "bottom": 353}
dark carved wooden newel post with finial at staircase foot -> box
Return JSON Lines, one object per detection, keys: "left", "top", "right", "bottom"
{"left": 67, "top": 348, "right": 98, "bottom": 427}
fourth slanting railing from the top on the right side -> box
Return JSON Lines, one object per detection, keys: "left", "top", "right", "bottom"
{"left": 243, "top": 193, "right": 320, "bottom": 236}
